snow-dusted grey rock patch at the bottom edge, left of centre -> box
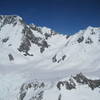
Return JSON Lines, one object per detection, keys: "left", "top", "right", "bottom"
{"left": 18, "top": 81, "right": 45, "bottom": 100}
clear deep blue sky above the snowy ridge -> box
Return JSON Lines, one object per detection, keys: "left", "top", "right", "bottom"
{"left": 0, "top": 0, "right": 100, "bottom": 33}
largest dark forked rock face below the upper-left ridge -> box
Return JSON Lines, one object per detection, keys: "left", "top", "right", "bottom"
{"left": 18, "top": 25, "right": 49, "bottom": 56}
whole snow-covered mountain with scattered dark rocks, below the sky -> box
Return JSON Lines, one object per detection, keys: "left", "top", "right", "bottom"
{"left": 0, "top": 15, "right": 100, "bottom": 100}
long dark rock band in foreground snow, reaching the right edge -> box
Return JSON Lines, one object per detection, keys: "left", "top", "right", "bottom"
{"left": 57, "top": 73, "right": 100, "bottom": 90}
